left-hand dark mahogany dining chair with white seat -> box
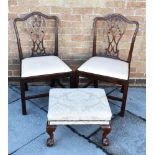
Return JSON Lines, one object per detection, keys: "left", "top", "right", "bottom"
{"left": 14, "top": 12, "right": 72, "bottom": 115}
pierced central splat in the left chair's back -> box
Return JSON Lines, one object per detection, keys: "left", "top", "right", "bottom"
{"left": 25, "top": 15, "right": 48, "bottom": 56}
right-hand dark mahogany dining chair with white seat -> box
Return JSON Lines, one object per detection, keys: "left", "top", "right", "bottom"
{"left": 76, "top": 14, "right": 139, "bottom": 117}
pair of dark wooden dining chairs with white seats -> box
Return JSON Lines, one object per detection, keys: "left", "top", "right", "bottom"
{"left": 13, "top": 12, "right": 139, "bottom": 116}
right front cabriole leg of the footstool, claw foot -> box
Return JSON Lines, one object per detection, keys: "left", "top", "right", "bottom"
{"left": 101, "top": 125, "right": 111, "bottom": 146}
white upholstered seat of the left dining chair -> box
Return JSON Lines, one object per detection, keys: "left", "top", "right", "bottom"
{"left": 21, "top": 56, "right": 72, "bottom": 77}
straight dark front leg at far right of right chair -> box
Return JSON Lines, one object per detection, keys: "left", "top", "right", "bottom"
{"left": 120, "top": 83, "right": 128, "bottom": 117}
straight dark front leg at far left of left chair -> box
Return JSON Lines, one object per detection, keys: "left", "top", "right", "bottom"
{"left": 20, "top": 80, "right": 26, "bottom": 115}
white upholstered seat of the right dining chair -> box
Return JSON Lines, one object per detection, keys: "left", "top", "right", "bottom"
{"left": 78, "top": 56, "right": 128, "bottom": 80}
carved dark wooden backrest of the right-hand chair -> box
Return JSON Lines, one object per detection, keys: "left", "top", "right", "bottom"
{"left": 93, "top": 14, "right": 139, "bottom": 63}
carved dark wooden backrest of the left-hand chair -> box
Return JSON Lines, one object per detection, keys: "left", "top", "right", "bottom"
{"left": 13, "top": 12, "right": 59, "bottom": 60}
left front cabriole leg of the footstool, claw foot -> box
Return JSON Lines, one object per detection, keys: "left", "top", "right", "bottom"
{"left": 46, "top": 122, "right": 56, "bottom": 147}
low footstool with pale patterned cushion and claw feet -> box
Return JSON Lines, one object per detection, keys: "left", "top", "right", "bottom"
{"left": 46, "top": 88, "right": 112, "bottom": 146}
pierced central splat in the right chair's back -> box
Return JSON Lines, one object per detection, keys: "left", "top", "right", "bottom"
{"left": 104, "top": 17, "right": 127, "bottom": 58}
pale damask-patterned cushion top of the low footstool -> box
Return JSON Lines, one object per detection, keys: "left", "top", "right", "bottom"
{"left": 47, "top": 88, "right": 112, "bottom": 124}
